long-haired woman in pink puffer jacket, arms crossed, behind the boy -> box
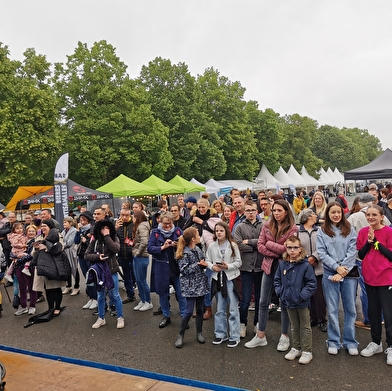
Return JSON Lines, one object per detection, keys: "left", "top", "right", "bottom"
{"left": 245, "top": 200, "right": 298, "bottom": 352}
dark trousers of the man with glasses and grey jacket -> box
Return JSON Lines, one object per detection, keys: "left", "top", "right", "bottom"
{"left": 240, "top": 270, "right": 263, "bottom": 326}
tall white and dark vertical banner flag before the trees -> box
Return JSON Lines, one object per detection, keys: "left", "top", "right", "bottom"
{"left": 54, "top": 153, "right": 69, "bottom": 227}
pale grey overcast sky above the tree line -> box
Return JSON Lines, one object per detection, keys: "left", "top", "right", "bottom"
{"left": 0, "top": 0, "right": 392, "bottom": 148}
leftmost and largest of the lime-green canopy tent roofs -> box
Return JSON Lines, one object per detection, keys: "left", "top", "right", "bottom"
{"left": 97, "top": 174, "right": 159, "bottom": 197}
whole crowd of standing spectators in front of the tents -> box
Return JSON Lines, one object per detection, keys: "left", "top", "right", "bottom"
{"left": 0, "top": 184, "right": 392, "bottom": 365}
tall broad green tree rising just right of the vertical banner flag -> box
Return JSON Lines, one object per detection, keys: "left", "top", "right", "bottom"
{"left": 53, "top": 41, "right": 172, "bottom": 187}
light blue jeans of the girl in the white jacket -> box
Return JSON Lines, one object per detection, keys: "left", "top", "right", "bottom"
{"left": 214, "top": 280, "right": 240, "bottom": 341}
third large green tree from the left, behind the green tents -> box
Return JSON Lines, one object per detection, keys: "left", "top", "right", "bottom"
{"left": 139, "top": 57, "right": 226, "bottom": 181}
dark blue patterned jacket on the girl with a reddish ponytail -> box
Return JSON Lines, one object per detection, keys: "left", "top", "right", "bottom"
{"left": 178, "top": 247, "right": 209, "bottom": 297}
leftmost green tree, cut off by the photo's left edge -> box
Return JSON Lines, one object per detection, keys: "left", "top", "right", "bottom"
{"left": 0, "top": 44, "right": 62, "bottom": 202}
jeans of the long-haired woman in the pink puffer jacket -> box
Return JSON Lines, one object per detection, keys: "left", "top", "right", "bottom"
{"left": 259, "top": 271, "right": 290, "bottom": 334}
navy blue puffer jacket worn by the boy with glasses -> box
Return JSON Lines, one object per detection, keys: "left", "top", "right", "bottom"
{"left": 274, "top": 258, "right": 317, "bottom": 308}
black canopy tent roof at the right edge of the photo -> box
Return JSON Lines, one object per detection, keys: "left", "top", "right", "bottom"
{"left": 344, "top": 148, "right": 392, "bottom": 181}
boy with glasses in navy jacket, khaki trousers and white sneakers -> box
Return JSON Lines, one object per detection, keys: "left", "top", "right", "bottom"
{"left": 274, "top": 236, "right": 317, "bottom": 364}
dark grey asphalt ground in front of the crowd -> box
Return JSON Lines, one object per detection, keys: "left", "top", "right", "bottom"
{"left": 0, "top": 278, "right": 392, "bottom": 390}
